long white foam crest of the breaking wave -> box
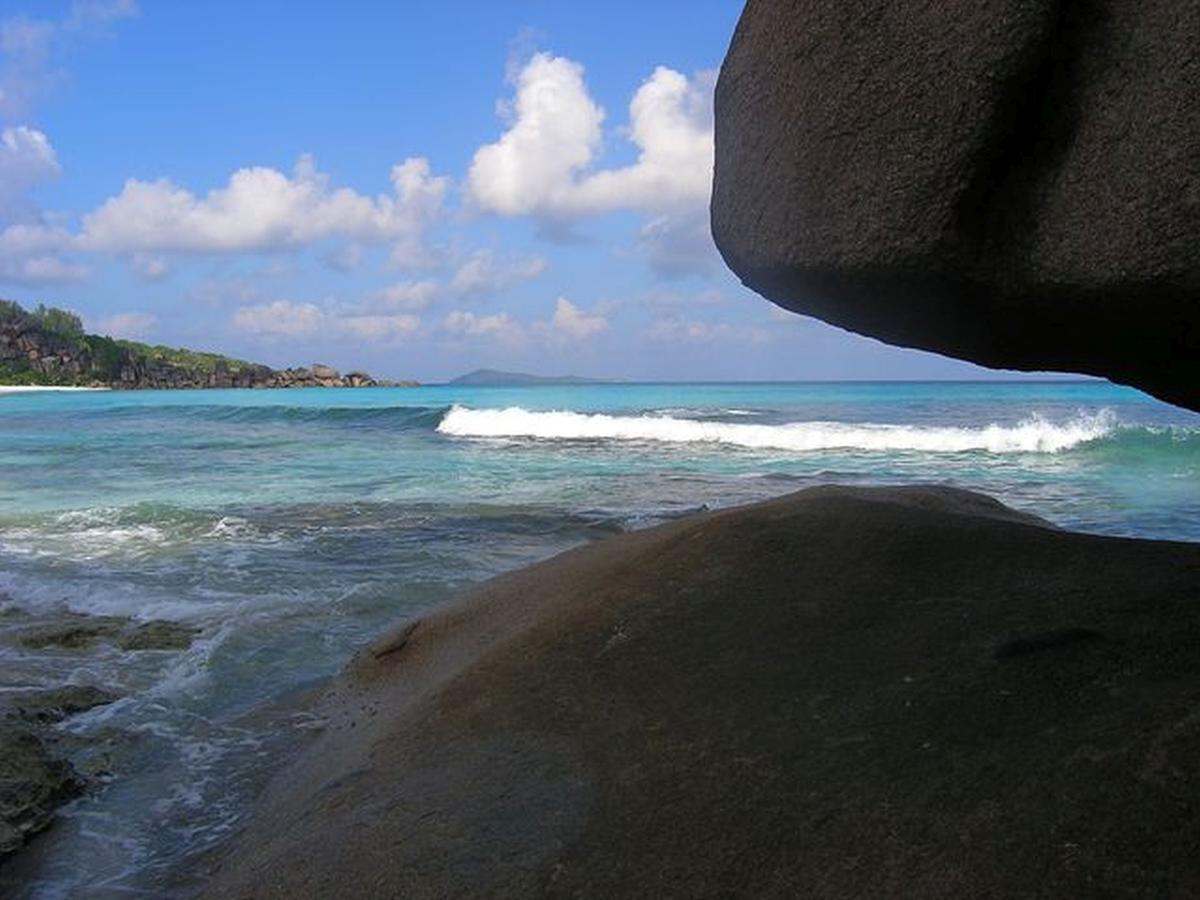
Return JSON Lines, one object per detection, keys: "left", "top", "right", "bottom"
{"left": 438, "top": 406, "right": 1117, "bottom": 454}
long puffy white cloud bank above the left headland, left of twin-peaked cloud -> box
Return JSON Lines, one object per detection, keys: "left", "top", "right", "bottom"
{"left": 79, "top": 156, "right": 448, "bottom": 265}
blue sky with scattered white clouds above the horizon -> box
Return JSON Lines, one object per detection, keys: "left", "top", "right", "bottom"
{"left": 0, "top": 0, "right": 1070, "bottom": 382}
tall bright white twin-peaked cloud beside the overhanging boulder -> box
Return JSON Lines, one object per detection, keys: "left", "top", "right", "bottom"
{"left": 467, "top": 53, "right": 715, "bottom": 220}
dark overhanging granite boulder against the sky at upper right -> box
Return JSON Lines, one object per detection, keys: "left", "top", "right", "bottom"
{"left": 713, "top": 0, "right": 1200, "bottom": 409}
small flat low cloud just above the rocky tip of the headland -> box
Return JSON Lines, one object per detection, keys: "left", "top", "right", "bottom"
{"left": 233, "top": 300, "right": 421, "bottom": 343}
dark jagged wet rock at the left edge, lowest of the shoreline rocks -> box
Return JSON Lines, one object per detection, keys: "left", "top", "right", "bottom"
{"left": 0, "top": 721, "right": 84, "bottom": 859}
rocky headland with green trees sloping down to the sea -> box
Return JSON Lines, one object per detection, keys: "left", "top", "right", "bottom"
{"left": 0, "top": 300, "right": 416, "bottom": 390}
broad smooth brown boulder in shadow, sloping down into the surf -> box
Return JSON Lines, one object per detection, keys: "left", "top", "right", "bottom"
{"left": 209, "top": 488, "right": 1200, "bottom": 899}
